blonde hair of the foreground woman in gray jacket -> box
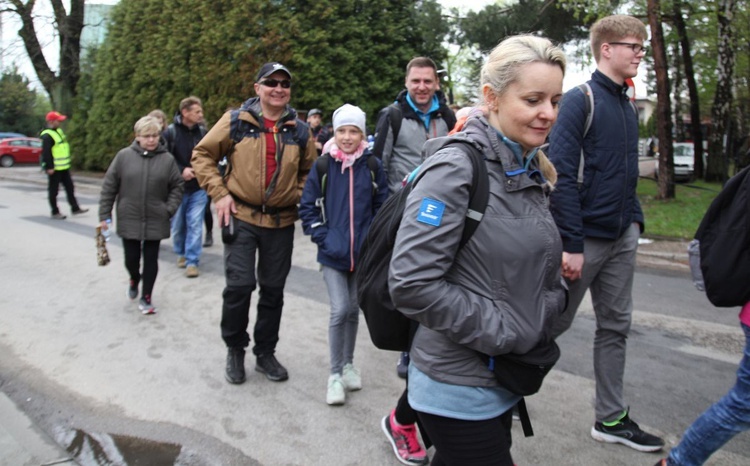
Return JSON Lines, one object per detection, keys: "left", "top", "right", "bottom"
{"left": 481, "top": 34, "right": 567, "bottom": 187}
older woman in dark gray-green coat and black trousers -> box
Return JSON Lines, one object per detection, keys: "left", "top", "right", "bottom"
{"left": 99, "top": 116, "right": 184, "bottom": 314}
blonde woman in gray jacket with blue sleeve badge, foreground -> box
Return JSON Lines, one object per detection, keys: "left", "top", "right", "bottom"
{"left": 389, "top": 36, "right": 566, "bottom": 466}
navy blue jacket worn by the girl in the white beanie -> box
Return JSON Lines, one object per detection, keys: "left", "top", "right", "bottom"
{"left": 299, "top": 149, "right": 388, "bottom": 272}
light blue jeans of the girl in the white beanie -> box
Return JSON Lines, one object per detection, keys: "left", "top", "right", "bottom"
{"left": 323, "top": 265, "right": 359, "bottom": 374}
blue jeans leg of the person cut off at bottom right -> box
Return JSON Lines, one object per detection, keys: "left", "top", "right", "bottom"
{"left": 667, "top": 324, "right": 750, "bottom": 466}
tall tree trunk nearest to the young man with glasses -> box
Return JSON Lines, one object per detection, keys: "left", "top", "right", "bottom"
{"left": 647, "top": 0, "right": 674, "bottom": 199}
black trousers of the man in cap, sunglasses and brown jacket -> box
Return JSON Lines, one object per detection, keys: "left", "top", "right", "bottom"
{"left": 221, "top": 218, "right": 294, "bottom": 356}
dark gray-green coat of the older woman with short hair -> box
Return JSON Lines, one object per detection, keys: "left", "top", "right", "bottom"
{"left": 99, "top": 141, "right": 185, "bottom": 240}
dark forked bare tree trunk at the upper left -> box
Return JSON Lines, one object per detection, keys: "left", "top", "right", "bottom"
{"left": 8, "top": 0, "right": 84, "bottom": 115}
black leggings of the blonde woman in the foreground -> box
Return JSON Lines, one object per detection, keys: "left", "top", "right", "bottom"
{"left": 417, "top": 409, "right": 513, "bottom": 466}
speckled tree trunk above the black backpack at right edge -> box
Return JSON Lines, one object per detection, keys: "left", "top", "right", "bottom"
{"left": 706, "top": 0, "right": 737, "bottom": 182}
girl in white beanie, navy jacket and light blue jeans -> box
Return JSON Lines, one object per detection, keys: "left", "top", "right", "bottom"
{"left": 299, "top": 104, "right": 388, "bottom": 405}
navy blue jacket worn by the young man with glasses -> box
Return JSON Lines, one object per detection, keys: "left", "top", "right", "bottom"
{"left": 548, "top": 70, "right": 645, "bottom": 253}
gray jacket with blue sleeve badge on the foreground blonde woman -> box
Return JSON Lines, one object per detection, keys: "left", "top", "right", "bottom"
{"left": 389, "top": 117, "right": 566, "bottom": 387}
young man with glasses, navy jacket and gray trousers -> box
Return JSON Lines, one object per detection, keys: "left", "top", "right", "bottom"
{"left": 549, "top": 15, "right": 664, "bottom": 452}
